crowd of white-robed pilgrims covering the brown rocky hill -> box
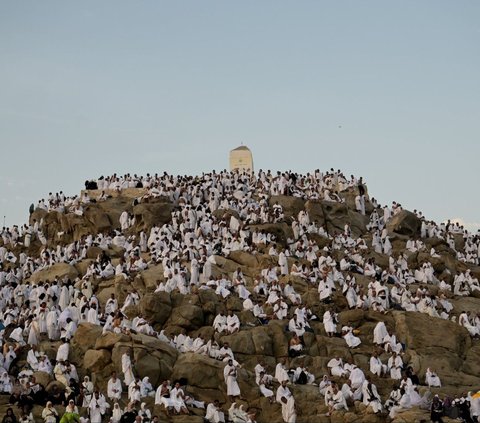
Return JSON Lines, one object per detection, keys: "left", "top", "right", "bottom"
{"left": 0, "top": 169, "right": 480, "bottom": 423}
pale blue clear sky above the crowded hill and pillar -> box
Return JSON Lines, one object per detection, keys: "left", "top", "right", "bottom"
{"left": 0, "top": 0, "right": 480, "bottom": 227}
